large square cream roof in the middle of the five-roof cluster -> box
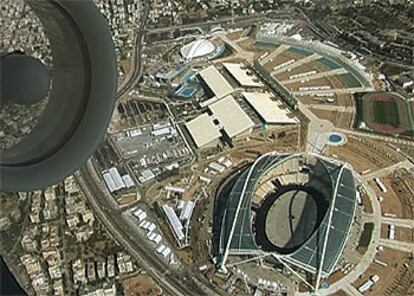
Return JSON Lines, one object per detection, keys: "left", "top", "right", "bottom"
{"left": 208, "top": 96, "right": 254, "bottom": 138}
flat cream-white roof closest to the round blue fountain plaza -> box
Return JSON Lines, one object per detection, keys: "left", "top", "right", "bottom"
{"left": 242, "top": 92, "right": 298, "bottom": 124}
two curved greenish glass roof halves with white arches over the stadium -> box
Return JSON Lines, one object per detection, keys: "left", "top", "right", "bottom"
{"left": 218, "top": 152, "right": 356, "bottom": 277}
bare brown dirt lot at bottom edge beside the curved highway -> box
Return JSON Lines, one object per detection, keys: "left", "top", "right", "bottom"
{"left": 123, "top": 273, "right": 162, "bottom": 296}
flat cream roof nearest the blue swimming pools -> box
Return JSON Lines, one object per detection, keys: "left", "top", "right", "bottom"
{"left": 199, "top": 65, "right": 233, "bottom": 99}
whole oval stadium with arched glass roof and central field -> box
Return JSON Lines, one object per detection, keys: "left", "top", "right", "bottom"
{"left": 213, "top": 153, "right": 357, "bottom": 277}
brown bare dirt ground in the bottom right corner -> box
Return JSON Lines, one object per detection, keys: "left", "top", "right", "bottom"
{"left": 353, "top": 248, "right": 412, "bottom": 296}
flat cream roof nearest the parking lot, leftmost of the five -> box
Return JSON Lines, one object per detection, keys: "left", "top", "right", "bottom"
{"left": 185, "top": 113, "right": 221, "bottom": 148}
